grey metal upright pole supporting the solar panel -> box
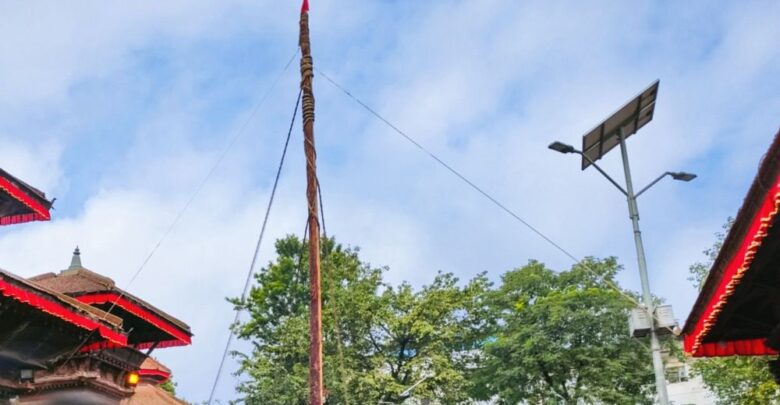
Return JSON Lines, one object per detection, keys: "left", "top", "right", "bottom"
{"left": 620, "top": 130, "right": 669, "bottom": 405}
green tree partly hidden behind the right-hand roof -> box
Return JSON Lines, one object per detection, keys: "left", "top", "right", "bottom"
{"left": 688, "top": 218, "right": 780, "bottom": 405}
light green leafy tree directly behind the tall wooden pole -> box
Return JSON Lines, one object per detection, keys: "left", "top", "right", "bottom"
{"left": 231, "top": 236, "right": 490, "bottom": 405}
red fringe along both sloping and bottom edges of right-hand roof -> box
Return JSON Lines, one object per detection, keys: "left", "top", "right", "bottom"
{"left": 684, "top": 177, "right": 780, "bottom": 357}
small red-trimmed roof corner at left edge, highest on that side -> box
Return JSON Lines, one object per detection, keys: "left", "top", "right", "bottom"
{"left": 0, "top": 169, "right": 52, "bottom": 225}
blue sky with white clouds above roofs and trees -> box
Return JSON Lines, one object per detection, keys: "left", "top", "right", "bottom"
{"left": 0, "top": 0, "right": 780, "bottom": 401}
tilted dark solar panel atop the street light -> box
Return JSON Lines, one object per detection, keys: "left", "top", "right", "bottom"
{"left": 582, "top": 80, "right": 659, "bottom": 170}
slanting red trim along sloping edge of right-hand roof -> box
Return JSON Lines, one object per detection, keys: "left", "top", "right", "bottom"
{"left": 685, "top": 176, "right": 780, "bottom": 357}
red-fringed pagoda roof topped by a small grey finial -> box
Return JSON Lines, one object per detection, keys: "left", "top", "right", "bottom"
{"left": 31, "top": 251, "right": 192, "bottom": 349}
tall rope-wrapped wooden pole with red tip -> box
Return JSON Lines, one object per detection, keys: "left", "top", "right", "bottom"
{"left": 299, "top": 0, "right": 323, "bottom": 405}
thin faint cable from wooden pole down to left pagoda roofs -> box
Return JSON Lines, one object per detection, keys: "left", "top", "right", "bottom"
{"left": 66, "top": 48, "right": 298, "bottom": 362}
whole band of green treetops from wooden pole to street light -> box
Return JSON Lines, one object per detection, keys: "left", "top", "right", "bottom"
{"left": 232, "top": 236, "right": 652, "bottom": 405}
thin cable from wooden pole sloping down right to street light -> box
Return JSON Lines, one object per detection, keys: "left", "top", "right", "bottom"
{"left": 314, "top": 67, "right": 671, "bottom": 330}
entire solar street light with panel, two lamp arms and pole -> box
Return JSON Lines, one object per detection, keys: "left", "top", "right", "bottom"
{"left": 549, "top": 81, "right": 696, "bottom": 405}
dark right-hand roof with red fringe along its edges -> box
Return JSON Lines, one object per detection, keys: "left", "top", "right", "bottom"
{"left": 683, "top": 128, "right": 780, "bottom": 357}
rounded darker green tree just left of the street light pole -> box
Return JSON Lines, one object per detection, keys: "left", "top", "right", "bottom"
{"left": 475, "top": 258, "right": 653, "bottom": 404}
